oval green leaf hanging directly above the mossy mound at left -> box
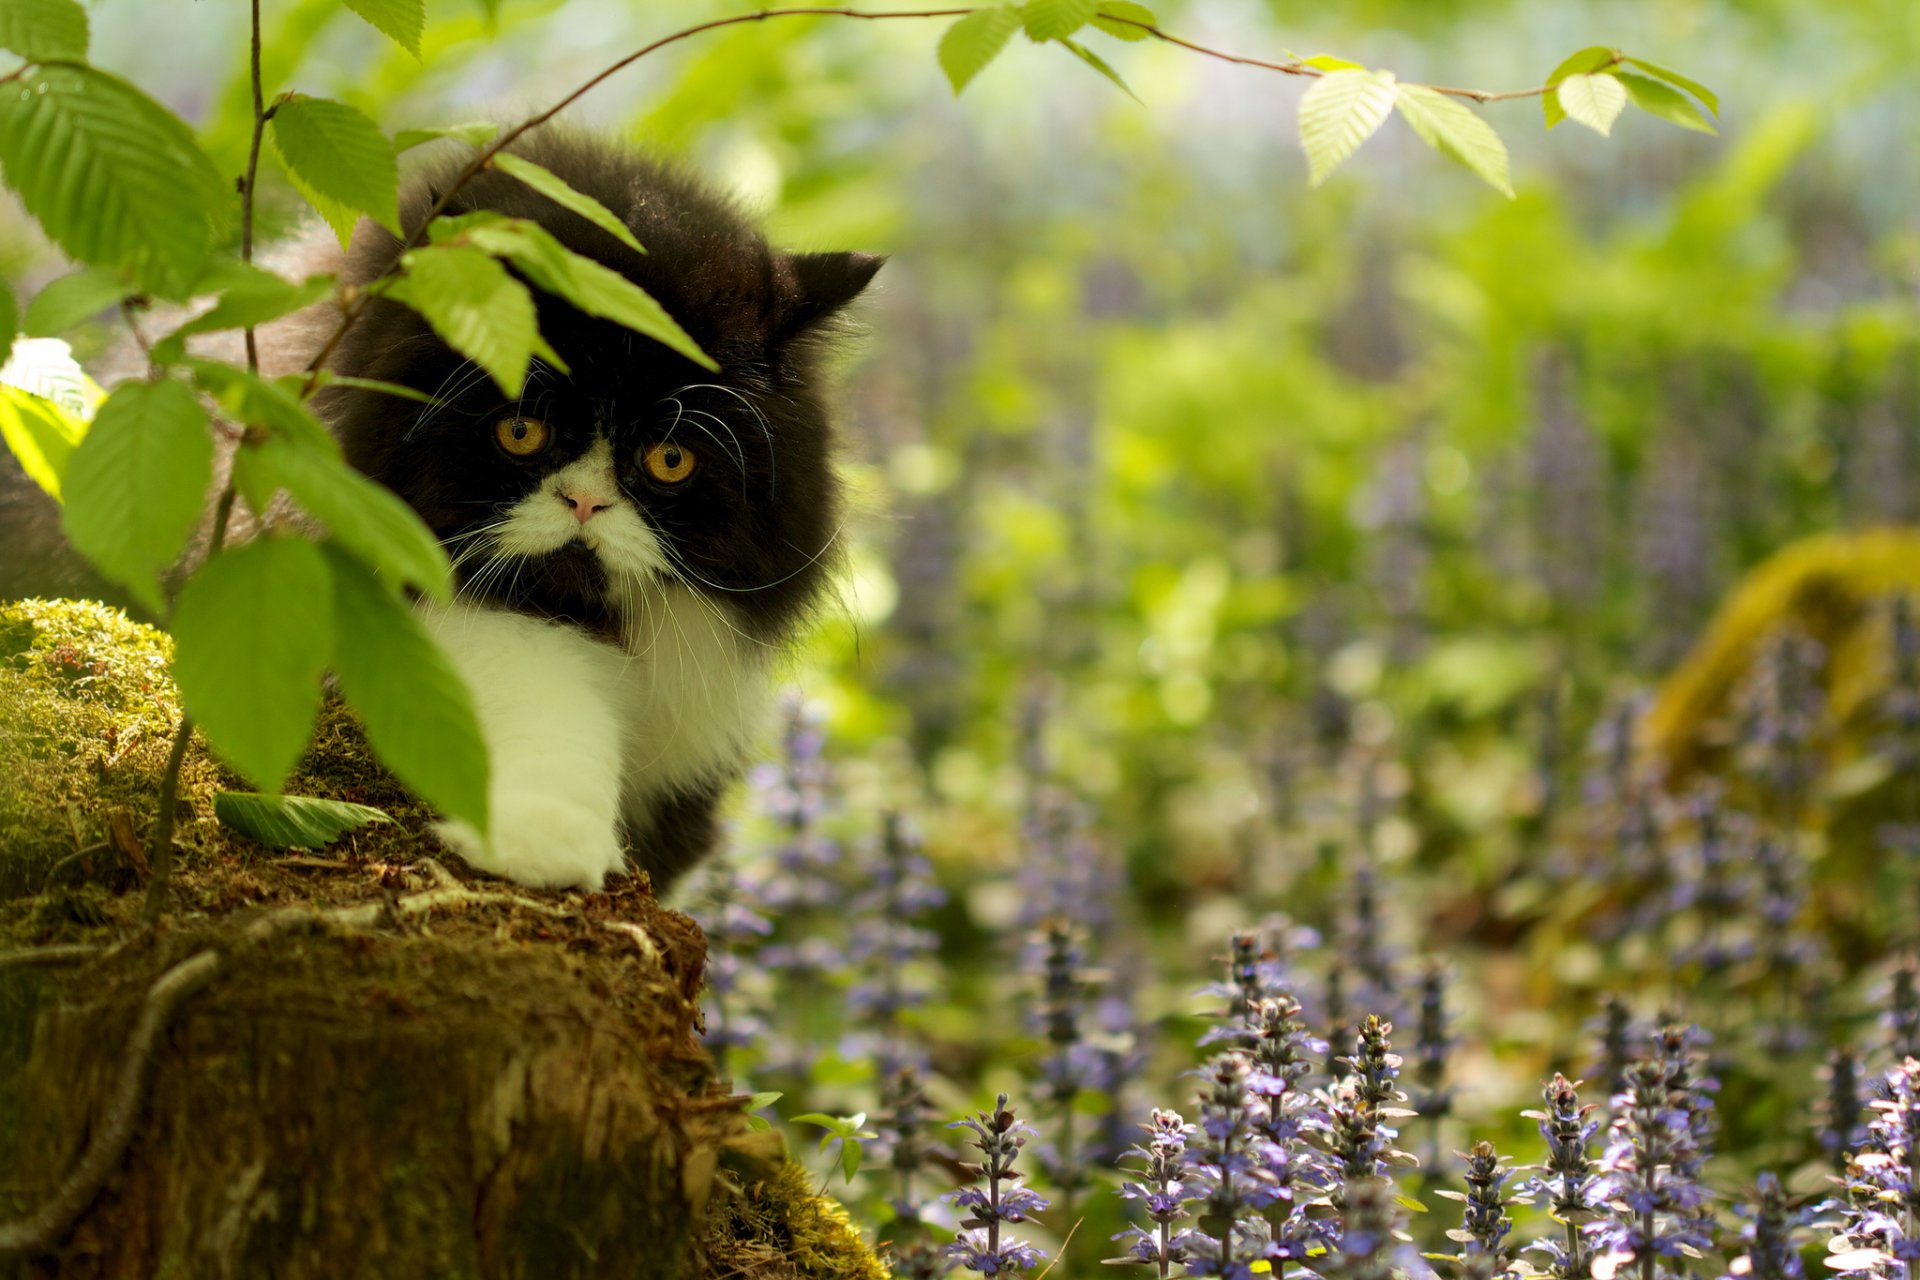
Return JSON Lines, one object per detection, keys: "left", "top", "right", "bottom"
{"left": 61, "top": 378, "right": 213, "bottom": 612}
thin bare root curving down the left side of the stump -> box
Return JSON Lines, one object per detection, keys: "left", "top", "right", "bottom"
{"left": 0, "top": 952, "right": 227, "bottom": 1257}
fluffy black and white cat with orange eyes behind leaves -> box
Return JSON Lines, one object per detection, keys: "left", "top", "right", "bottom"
{"left": 299, "top": 132, "right": 879, "bottom": 889}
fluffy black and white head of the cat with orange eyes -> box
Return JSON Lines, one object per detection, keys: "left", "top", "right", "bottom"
{"left": 321, "top": 134, "right": 879, "bottom": 639}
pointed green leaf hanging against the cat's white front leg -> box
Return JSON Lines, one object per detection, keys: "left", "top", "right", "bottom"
{"left": 324, "top": 543, "right": 488, "bottom": 833}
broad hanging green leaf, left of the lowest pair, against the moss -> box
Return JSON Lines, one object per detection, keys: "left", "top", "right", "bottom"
{"left": 171, "top": 537, "right": 334, "bottom": 791}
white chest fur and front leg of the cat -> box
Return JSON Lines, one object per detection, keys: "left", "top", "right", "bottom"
{"left": 420, "top": 580, "right": 770, "bottom": 889}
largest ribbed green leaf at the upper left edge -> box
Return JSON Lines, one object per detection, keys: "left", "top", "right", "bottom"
{"left": 0, "top": 65, "right": 228, "bottom": 294}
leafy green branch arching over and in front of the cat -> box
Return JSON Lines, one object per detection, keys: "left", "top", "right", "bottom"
{"left": 0, "top": 0, "right": 1718, "bottom": 917}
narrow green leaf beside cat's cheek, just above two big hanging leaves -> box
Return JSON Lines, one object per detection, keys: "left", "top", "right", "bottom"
{"left": 234, "top": 438, "right": 453, "bottom": 601}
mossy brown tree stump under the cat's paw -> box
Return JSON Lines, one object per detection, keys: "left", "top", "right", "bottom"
{"left": 0, "top": 603, "right": 883, "bottom": 1280}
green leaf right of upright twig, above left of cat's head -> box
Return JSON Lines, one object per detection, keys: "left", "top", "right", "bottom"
{"left": 273, "top": 94, "right": 401, "bottom": 246}
